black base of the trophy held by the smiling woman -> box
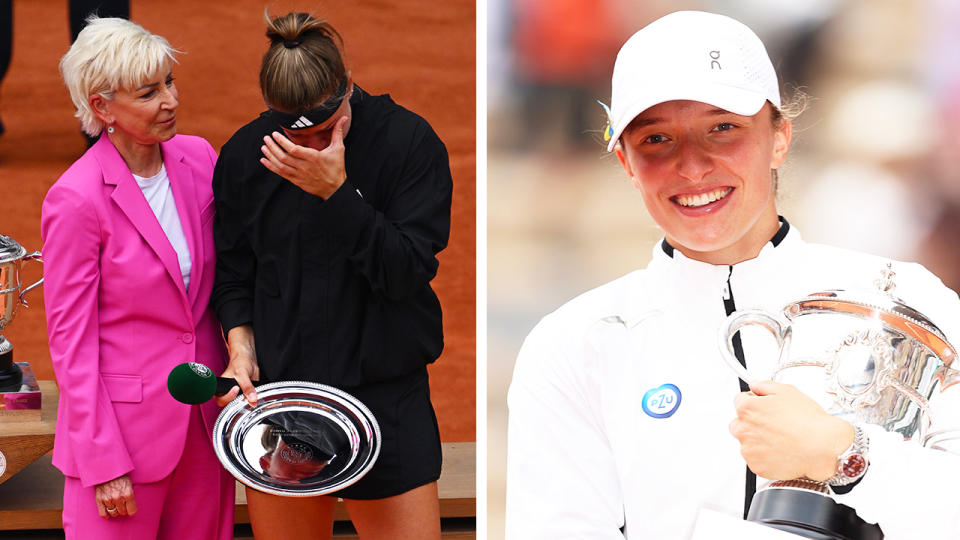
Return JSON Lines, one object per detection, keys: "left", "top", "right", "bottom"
{"left": 747, "top": 487, "right": 883, "bottom": 540}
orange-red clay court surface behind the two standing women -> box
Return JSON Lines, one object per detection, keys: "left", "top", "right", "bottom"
{"left": 0, "top": 0, "right": 476, "bottom": 441}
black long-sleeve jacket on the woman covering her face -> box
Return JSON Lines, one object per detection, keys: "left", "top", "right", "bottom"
{"left": 211, "top": 88, "right": 453, "bottom": 388}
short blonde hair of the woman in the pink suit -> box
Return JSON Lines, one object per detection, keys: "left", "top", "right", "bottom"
{"left": 60, "top": 15, "right": 179, "bottom": 137}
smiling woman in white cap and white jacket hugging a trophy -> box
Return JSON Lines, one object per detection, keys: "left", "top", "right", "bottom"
{"left": 506, "top": 11, "right": 960, "bottom": 540}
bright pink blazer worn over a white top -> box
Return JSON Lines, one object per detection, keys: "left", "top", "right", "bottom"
{"left": 41, "top": 135, "right": 226, "bottom": 486}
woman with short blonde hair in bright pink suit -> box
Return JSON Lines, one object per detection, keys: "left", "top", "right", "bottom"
{"left": 41, "top": 18, "right": 234, "bottom": 540}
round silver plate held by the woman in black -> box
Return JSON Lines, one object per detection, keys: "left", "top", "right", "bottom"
{"left": 213, "top": 381, "right": 381, "bottom": 497}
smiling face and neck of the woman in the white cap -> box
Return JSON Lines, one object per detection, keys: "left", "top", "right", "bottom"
{"left": 615, "top": 100, "right": 792, "bottom": 264}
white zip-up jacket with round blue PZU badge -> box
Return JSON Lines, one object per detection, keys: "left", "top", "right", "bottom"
{"left": 506, "top": 221, "right": 960, "bottom": 540}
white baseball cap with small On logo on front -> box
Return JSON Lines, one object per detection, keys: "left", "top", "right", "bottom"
{"left": 607, "top": 11, "right": 780, "bottom": 152}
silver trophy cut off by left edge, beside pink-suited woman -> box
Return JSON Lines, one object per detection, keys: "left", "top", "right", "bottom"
{"left": 0, "top": 234, "right": 43, "bottom": 392}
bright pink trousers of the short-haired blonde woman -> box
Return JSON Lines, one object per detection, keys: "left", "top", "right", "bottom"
{"left": 63, "top": 406, "right": 235, "bottom": 540}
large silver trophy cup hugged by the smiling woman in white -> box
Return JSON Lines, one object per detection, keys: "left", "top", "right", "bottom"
{"left": 719, "top": 265, "right": 960, "bottom": 540}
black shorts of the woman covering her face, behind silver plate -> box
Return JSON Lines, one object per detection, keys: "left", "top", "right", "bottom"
{"left": 330, "top": 367, "right": 442, "bottom": 499}
